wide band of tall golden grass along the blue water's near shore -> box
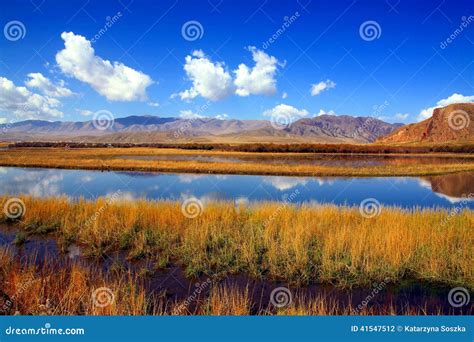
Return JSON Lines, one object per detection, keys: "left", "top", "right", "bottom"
{"left": 0, "top": 196, "right": 474, "bottom": 289}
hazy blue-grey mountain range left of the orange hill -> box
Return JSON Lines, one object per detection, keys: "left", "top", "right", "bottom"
{"left": 0, "top": 115, "right": 401, "bottom": 143}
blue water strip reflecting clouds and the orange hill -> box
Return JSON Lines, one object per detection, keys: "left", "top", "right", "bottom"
{"left": 0, "top": 167, "right": 474, "bottom": 209}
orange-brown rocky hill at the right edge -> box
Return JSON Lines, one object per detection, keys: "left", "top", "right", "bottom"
{"left": 377, "top": 103, "right": 474, "bottom": 143}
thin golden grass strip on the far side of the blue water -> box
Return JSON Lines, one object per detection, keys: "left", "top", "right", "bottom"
{"left": 0, "top": 148, "right": 474, "bottom": 176}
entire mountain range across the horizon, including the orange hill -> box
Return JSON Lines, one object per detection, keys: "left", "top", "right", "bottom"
{"left": 0, "top": 103, "right": 474, "bottom": 144}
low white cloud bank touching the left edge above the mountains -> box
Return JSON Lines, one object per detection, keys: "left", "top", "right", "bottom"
{"left": 0, "top": 77, "right": 64, "bottom": 119}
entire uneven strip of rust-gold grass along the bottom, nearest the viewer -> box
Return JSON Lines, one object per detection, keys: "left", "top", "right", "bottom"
{"left": 0, "top": 248, "right": 441, "bottom": 315}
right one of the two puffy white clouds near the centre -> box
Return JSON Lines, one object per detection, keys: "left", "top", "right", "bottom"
{"left": 234, "top": 46, "right": 278, "bottom": 96}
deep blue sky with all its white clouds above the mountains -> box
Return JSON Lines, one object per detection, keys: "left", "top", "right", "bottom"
{"left": 0, "top": 0, "right": 474, "bottom": 122}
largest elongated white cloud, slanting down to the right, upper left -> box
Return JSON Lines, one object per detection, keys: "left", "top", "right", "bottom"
{"left": 56, "top": 32, "right": 153, "bottom": 101}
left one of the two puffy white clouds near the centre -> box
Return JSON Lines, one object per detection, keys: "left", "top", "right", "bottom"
{"left": 179, "top": 50, "right": 233, "bottom": 101}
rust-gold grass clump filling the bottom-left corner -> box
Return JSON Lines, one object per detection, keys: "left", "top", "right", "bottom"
{"left": 0, "top": 248, "right": 146, "bottom": 315}
